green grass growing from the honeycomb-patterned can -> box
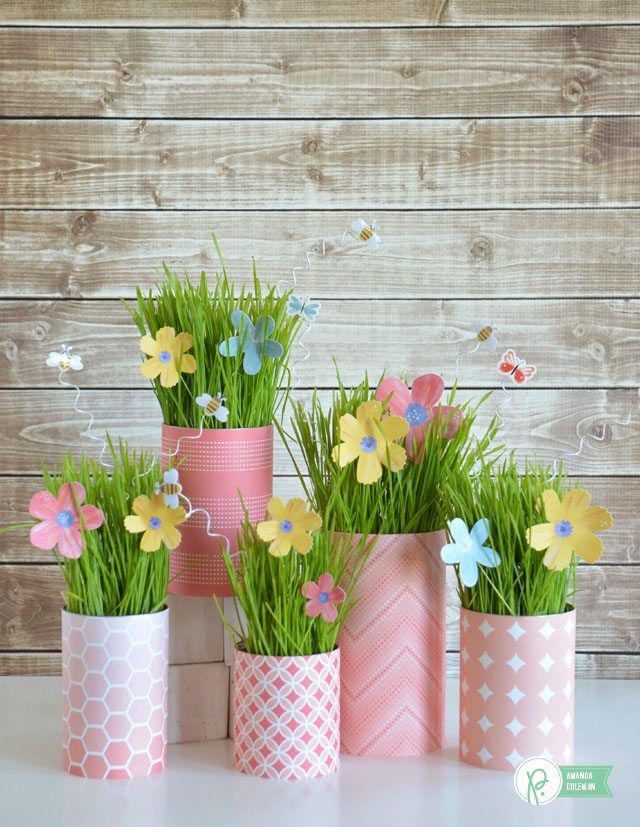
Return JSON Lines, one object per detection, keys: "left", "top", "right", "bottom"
{"left": 43, "top": 440, "right": 169, "bottom": 616}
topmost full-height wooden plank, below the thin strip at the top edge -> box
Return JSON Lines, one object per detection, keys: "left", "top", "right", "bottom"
{"left": 0, "top": 26, "right": 640, "bottom": 118}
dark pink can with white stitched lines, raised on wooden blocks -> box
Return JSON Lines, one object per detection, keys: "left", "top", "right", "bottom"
{"left": 162, "top": 425, "right": 273, "bottom": 597}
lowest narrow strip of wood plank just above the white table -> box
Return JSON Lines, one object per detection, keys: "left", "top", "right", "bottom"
{"left": 0, "top": 652, "right": 640, "bottom": 680}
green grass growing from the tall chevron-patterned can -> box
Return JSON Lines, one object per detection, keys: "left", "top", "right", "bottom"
{"left": 283, "top": 376, "right": 498, "bottom": 534}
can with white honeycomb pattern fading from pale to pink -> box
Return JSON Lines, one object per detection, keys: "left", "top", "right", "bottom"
{"left": 62, "top": 609, "right": 169, "bottom": 778}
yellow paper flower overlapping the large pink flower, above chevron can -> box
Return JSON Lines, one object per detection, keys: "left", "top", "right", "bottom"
{"left": 331, "top": 401, "right": 409, "bottom": 485}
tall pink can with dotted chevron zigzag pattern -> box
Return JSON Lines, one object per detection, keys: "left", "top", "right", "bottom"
{"left": 339, "top": 531, "right": 446, "bottom": 757}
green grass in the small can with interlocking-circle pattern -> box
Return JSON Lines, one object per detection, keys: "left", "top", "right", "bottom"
{"left": 216, "top": 520, "right": 371, "bottom": 656}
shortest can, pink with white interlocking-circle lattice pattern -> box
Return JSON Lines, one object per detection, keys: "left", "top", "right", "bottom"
{"left": 233, "top": 649, "right": 340, "bottom": 780}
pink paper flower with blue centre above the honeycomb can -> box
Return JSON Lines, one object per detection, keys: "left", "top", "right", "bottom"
{"left": 29, "top": 482, "right": 103, "bottom": 559}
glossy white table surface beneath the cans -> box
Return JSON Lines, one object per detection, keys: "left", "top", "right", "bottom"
{"left": 0, "top": 677, "right": 640, "bottom": 827}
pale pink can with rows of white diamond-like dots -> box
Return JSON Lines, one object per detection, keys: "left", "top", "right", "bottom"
{"left": 459, "top": 609, "right": 576, "bottom": 772}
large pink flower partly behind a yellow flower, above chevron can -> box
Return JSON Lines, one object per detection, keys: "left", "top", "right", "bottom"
{"left": 376, "top": 373, "right": 461, "bottom": 460}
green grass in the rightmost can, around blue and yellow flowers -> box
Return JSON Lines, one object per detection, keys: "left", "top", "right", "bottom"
{"left": 444, "top": 453, "right": 577, "bottom": 616}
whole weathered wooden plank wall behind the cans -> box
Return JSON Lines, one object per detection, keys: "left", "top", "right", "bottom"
{"left": 0, "top": 0, "right": 640, "bottom": 678}
